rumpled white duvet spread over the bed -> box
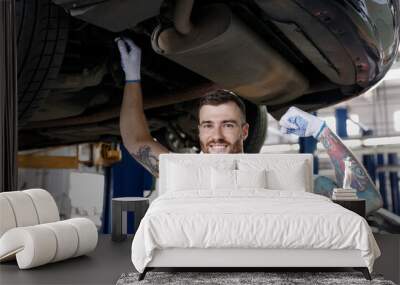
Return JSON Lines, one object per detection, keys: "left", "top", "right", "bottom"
{"left": 132, "top": 189, "right": 380, "bottom": 272}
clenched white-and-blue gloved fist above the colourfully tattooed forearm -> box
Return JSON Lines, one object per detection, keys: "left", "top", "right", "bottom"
{"left": 279, "top": 107, "right": 326, "bottom": 140}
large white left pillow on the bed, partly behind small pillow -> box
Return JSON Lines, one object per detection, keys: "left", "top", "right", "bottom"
{"left": 166, "top": 161, "right": 235, "bottom": 191}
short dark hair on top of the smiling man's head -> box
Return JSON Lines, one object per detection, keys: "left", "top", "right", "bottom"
{"left": 198, "top": 89, "right": 246, "bottom": 123}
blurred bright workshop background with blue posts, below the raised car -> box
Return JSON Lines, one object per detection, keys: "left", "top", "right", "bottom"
{"left": 13, "top": 59, "right": 400, "bottom": 233}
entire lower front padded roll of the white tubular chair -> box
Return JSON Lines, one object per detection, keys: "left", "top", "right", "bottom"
{"left": 0, "top": 218, "right": 98, "bottom": 269}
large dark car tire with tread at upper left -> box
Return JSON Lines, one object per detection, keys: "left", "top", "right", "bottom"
{"left": 15, "top": 0, "right": 68, "bottom": 124}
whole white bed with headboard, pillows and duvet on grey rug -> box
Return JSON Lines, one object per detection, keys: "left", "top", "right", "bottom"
{"left": 132, "top": 154, "right": 380, "bottom": 279}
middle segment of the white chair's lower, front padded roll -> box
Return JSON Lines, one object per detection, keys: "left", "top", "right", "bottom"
{"left": 42, "top": 221, "right": 78, "bottom": 262}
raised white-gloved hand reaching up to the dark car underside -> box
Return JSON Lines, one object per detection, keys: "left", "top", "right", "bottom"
{"left": 115, "top": 38, "right": 141, "bottom": 83}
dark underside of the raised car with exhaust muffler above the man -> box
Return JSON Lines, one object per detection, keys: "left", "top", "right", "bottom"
{"left": 16, "top": 0, "right": 400, "bottom": 152}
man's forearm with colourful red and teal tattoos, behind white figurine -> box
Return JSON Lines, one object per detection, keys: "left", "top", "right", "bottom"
{"left": 320, "top": 127, "right": 382, "bottom": 213}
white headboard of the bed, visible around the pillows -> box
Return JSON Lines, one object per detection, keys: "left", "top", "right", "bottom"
{"left": 159, "top": 153, "right": 313, "bottom": 195}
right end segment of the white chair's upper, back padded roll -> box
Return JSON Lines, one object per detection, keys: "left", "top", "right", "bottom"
{"left": 22, "top": 189, "right": 60, "bottom": 224}
